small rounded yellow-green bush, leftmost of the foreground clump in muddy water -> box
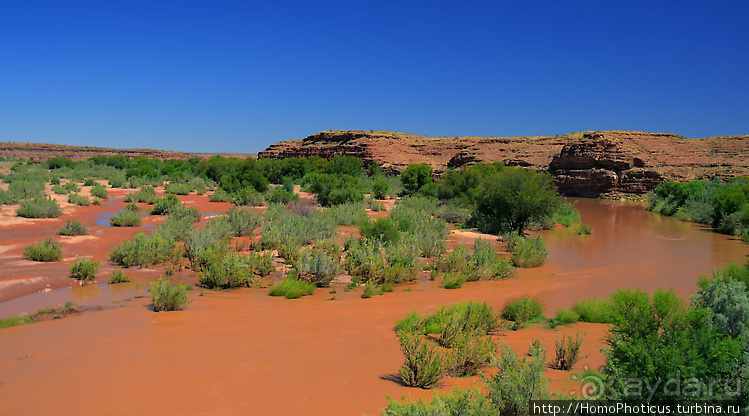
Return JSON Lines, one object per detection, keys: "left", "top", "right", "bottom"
{"left": 398, "top": 332, "right": 447, "bottom": 389}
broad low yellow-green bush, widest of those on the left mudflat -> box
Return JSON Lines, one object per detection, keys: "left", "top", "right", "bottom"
{"left": 109, "top": 233, "right": 182, "bottom": 267}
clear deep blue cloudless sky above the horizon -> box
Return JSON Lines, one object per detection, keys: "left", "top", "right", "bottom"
{"left": 0, "top": 0, "right": 749, "bottom": 152}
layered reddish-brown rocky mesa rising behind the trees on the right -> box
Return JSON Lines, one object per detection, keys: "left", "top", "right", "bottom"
{"left": 258, "top": 130, "right": 749, "bottom": 196}
